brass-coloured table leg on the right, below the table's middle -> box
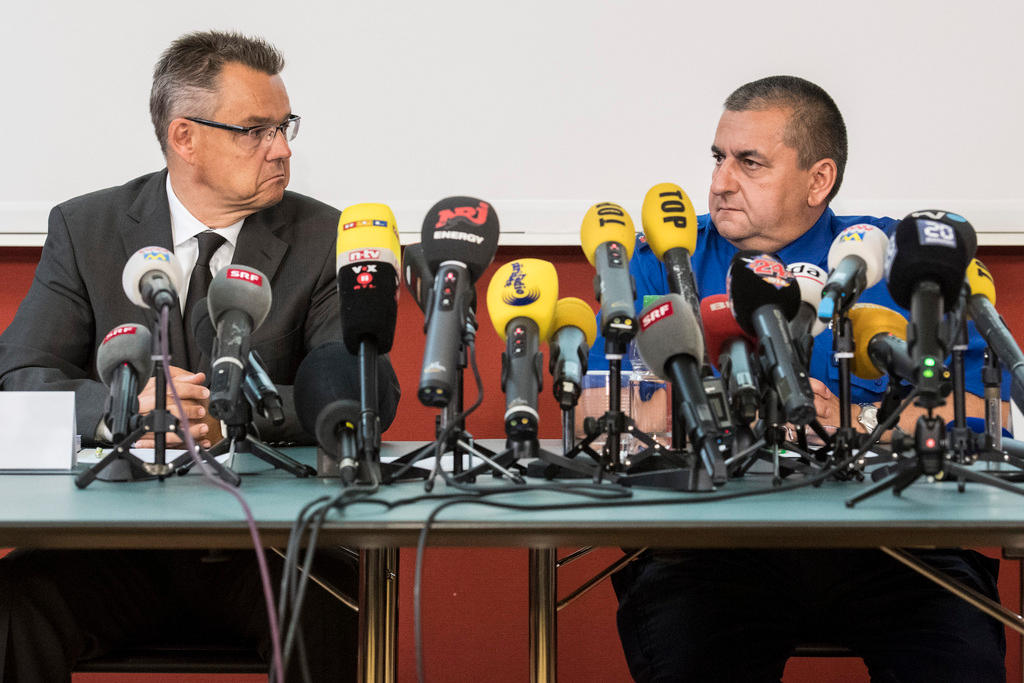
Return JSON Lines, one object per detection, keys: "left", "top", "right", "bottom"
{"left": 529, "top": 548, "right": 558, "bottom": 683}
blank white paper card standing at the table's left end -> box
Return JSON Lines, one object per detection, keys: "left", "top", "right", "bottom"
{"left": 0, "top": 391, "right": 76, "bottom": 470}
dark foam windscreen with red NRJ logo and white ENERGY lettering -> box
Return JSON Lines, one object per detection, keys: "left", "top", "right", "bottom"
{"left": 420, "top": 197, "right": 500, "bottom": 283}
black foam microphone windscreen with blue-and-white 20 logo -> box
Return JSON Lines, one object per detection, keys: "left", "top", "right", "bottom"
{"left": 886, "top": 210, "right": 978, "bottom": 309}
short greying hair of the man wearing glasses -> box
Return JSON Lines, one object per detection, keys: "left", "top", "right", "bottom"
{"left": 150, "top": 31, "right": 285, "bottom": 157}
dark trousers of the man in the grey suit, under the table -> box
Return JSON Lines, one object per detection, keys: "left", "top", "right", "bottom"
{"left": 0, "top": 550, "right": 358, "bottom": 683}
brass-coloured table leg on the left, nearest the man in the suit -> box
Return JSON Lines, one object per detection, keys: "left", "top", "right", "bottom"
{"left": 358, "top": 548, "right": 398, "bottom": 683}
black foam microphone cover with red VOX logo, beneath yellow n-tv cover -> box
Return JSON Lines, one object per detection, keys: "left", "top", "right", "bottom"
{"left": 338, "top": 255, "right": 399, "bottom": 353}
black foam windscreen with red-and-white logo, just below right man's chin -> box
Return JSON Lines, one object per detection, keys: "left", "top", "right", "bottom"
{"left": 725, "top": 251, "right": 800, "bottom": 336}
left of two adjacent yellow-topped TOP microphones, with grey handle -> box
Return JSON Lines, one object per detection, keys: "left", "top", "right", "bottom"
{"left": 580, "top": 202, "right": 636, "bottom": 353}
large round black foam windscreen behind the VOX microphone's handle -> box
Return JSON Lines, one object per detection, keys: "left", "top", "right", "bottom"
{"left": 293, "top": 341, "right": 398, "bottom": 436}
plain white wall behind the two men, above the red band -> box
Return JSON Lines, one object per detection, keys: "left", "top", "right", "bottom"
{"left": 0, "top": 0, "right": 1024, "bottom": 244}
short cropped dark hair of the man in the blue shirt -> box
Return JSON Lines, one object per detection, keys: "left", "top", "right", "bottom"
{"left": 725, "top": 76, "right": 847, "bottom": 202}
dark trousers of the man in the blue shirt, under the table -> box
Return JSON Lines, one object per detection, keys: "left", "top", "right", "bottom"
{"left": 612, "top": 550, "right": 1006, "bottom": 683}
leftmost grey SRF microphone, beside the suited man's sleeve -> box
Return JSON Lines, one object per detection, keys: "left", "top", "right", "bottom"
{"left": 96, "top": 323, "right": 154, "bottom": 443}
